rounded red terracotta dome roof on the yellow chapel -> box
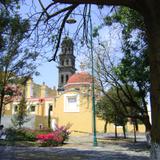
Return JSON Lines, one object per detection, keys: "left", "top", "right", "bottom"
{"left": 67, "top": 72, "right": 92, "bottom": 84}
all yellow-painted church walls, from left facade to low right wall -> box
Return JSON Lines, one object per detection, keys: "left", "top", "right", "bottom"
{"left": 5, "top": 80, "right": 145, "bottom": 133}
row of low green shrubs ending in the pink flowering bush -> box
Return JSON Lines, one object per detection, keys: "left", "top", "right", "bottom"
{"left": 6, "top": 126, "right": 70, "bottom": 146}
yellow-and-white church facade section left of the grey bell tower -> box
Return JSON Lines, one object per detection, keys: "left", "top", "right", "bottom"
{"left": 2, "top": 79, "right": 57, "bottom": 128}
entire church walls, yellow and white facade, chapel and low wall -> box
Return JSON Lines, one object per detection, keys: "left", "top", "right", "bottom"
{"left": 2, "top": 81, "right": 145, "bottom": 134}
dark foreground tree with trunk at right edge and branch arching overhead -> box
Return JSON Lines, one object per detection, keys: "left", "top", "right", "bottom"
{"left": 26, "top": 0, "right": 160, "bottom": 160}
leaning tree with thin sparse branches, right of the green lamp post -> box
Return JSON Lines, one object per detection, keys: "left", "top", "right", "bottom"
{"left": 92, "top": 43, "right": 151, "bottom": 131}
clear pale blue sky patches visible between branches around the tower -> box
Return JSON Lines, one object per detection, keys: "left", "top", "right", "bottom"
{"left": 21, "top": 0, "right": 121, "bottom": 88}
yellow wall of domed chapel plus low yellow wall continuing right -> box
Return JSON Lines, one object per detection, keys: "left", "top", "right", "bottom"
{"left": 53, "top": 91, "right": 145, "bottom": 133}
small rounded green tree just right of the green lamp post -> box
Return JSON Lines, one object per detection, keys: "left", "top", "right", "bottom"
{"left": 96, "top": 88, "right": 127, "bottom": 138}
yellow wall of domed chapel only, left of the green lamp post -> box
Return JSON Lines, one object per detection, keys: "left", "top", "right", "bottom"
{"left": 53, "top": 92, "right": 92, "bottom": 133}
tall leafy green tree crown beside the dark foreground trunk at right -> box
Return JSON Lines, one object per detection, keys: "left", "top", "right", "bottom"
{"left": 94, "top": 7, "right": 151, "bottom": 141}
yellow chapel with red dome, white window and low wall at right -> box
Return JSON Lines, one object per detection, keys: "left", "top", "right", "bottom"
{"left": 53, "top": 72, "right": 145, "bottom": 133}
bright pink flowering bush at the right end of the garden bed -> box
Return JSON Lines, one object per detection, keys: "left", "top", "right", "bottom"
{"left": 36, "top": 126, "right": 70, "bottom": 146}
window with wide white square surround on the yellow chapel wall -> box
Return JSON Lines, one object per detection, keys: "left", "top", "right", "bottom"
{"left": 64, "top": 94, "right": 79, "bottom": 112}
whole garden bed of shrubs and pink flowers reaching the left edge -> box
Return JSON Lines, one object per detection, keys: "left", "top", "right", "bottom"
{"left": 0, "top": 126, "right": 70, "bottom": 147}
